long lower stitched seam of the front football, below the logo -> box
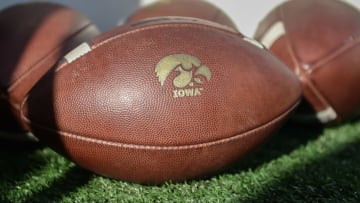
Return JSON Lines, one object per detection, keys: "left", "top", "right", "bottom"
{"left": 21, "top": 99, "right": 300, "bottom": 151}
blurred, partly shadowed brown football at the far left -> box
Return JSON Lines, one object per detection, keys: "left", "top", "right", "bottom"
{"left": 0, "top": 2, "right": 99, "bottom": 138}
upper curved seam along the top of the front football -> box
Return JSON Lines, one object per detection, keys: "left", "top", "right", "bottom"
{"left": 55, "top": 18, "right": 244, "bottom": 72}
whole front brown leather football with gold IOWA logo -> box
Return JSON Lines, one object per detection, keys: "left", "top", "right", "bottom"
{"left": 21, "top": 17, "right": 301, "bottom": 184}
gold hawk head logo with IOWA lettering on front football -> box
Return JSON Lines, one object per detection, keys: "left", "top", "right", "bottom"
{"left": 155, "top": 54, "right": 211, "bottom": 98}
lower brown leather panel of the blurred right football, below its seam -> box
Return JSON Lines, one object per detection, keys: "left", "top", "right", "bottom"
{"left": 311, "top": 40, "right": 360, "bottom": 121}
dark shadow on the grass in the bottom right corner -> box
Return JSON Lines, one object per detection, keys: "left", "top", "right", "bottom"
{"left": 248, "top": 127, "right": 360, "bottom": 202}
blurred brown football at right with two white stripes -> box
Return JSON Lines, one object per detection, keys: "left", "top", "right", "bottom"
{"left": 255, "top": 0, "right": 360, "bottom": 124}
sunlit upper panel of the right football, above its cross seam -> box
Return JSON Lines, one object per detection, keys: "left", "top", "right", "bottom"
{"left": 281, "top": 0, "right": 360, "bottom": 64}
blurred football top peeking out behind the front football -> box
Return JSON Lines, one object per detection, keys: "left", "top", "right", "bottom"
{"left": 126, "top": 0, "right": 236, "bottom": 29}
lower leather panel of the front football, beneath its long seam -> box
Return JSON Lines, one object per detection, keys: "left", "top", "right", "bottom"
{"left": 24, "top": 105, "right": 296, "bottom": 184}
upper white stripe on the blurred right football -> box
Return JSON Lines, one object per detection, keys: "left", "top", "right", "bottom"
{"left": 260, "top": 21, "right": 286, "bottom": 49}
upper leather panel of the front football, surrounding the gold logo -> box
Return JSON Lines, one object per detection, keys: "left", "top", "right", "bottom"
{"left": 23, "top": 21, "right": 301, "bottom": 145}
